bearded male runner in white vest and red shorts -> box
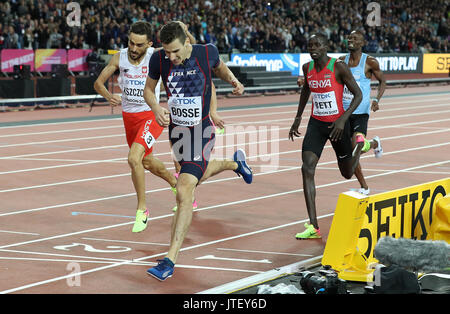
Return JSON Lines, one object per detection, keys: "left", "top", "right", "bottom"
{"left": 94, "top": 21, "right": 197, "bottom": 232}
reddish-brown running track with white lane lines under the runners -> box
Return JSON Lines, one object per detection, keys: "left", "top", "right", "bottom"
{"left": 0, "top": 85, "right": 450, "bottom": 294}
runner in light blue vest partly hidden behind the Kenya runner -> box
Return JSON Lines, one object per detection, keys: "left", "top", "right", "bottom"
{"left": 340, "top": 30, "right": 386, "bottom": 195}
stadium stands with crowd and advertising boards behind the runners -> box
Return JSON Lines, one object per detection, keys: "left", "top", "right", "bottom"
{"left": 0, "top": 0, "right": 450, "bottom": 111}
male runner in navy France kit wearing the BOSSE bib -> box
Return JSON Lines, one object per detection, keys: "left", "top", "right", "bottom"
{"left": 144, "top": 22, "right": 253, "bottom": 281}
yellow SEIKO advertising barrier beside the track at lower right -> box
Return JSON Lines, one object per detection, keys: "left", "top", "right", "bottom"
{"left": 322, "top": 178, "right": 450, "bottom": 282}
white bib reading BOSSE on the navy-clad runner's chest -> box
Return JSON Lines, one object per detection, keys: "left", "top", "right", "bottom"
{"left": 168, "top": 96, "right": 202, "bottom": 126}
